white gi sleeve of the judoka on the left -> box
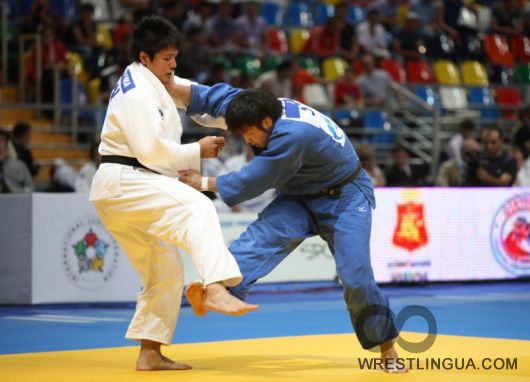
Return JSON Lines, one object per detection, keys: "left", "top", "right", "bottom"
{"left": 119, "top": 96, "right": 201, "bottom": 175}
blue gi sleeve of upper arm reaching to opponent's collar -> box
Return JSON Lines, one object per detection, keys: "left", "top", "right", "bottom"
{"left": 187, "top": 84, "right": 241, "bottom": 118}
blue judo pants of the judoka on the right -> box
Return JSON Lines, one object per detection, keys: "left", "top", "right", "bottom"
{"left": 229, "top": 182, "right": 398, "bottom": 349}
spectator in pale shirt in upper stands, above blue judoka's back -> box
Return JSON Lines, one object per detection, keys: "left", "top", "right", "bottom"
{"left": 356, "top": 9, "right": 390, "bottom": 57}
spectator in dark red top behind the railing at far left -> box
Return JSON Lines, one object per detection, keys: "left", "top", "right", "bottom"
{"left": 27, "top": 25, "right": 68, "bottom": 118}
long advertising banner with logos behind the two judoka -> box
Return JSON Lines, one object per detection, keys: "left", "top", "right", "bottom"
{"left": 27, "top": 188, "right": 530, "bottom": 303}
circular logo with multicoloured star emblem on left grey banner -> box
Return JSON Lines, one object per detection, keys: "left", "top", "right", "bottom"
{"left": 62, "top": 216, "right": 120, "bottom": 290}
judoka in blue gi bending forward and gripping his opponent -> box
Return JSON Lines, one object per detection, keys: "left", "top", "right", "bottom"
{"left": 174, "top": 84, "right": 404, "bottom": 372}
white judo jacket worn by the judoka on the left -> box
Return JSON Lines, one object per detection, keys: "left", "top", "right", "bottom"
{"left": 89, "top": 62, "right": 221, "bottom": 201}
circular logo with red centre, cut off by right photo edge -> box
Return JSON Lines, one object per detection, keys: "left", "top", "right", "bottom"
{"left": 490, "top": 194, "right": 530, "bottom": 276}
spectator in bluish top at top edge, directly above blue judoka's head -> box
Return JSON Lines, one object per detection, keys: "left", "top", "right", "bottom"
{"left": 235, "top": 1, "right": 268, "bottom": 58}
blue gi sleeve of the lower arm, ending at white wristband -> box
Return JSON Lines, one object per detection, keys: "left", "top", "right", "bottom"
{"left": 217, "top": 126, "right": 310, "bottom": 206}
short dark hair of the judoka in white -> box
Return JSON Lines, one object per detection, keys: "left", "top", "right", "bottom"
{"left": 131, "top": 15, "right": 180, "bottom": 62}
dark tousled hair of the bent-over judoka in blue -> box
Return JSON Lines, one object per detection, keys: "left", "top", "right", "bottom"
{"left": 225, "top": 89, "right": 283, "bottom": 134}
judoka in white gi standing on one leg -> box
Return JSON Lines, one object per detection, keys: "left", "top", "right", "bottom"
{"left": 89, "top": 16, "right": 257, "bottom": 370}
